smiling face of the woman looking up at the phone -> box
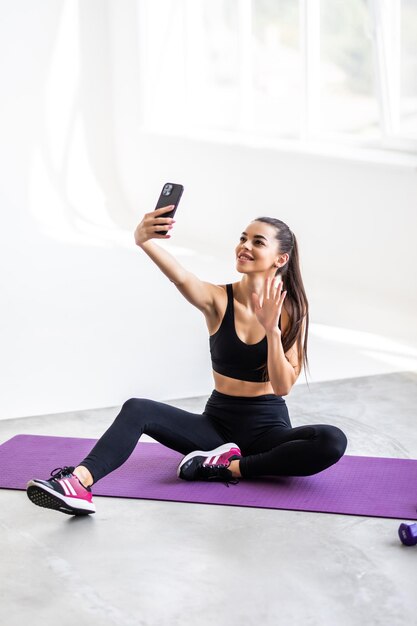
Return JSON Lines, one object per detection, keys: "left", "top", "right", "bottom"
{"left": 236, "top": 221, "right": 282, "bottom": 274}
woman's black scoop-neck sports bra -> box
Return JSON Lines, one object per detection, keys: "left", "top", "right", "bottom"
{"left": 210, "top": 284, "right": 269, "bottom": 383}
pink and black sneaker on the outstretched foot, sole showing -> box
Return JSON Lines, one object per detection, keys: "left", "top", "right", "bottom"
{"left": 26, "top": 467, "right": 96, "bottom": 515}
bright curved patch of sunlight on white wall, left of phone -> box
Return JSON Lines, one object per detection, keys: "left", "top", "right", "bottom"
{"left": 28, "top": 0, "right": 131, "bottom": 247}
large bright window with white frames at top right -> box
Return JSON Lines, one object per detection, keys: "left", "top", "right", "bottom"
{"left": 138, "top": 0, "right": 417, "bottom": 152}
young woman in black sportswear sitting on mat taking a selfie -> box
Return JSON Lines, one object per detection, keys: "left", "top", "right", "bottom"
{"left": 27, "top": 207, "right": 347, "bottom": 515}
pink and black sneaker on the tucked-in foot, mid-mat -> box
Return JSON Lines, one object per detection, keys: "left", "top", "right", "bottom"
{"left": 177, "top": 443, "right": 242, "bottom": 486}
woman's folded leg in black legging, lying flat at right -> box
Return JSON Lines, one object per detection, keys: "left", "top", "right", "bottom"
{"left": 236, "top": 424, "right": 347, "bottom": 478}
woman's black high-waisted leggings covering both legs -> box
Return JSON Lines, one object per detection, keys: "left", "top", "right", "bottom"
{"left": 79, "top": 390, "right": 347, "bottom": 482}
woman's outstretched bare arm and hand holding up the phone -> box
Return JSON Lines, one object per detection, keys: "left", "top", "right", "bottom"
{"left": 135, "top": 207, "right": 219, "bottom": 314}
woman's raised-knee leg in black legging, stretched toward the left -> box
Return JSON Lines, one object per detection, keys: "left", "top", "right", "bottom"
{"left": 74, "top": 398, "right": 225, "bottom": 486}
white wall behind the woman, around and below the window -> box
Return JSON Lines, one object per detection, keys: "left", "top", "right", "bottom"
{"left": 0, "top": 0, "right": 417, "bottom": 419}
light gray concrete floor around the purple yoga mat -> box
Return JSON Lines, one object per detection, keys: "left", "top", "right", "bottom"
{"left": 0, "top": 374, "right": 417, "bottom": 626}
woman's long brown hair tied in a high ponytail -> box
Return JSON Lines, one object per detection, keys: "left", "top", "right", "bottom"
{"left": 254, "top": 217, "right": 309, "bottom": 379}
